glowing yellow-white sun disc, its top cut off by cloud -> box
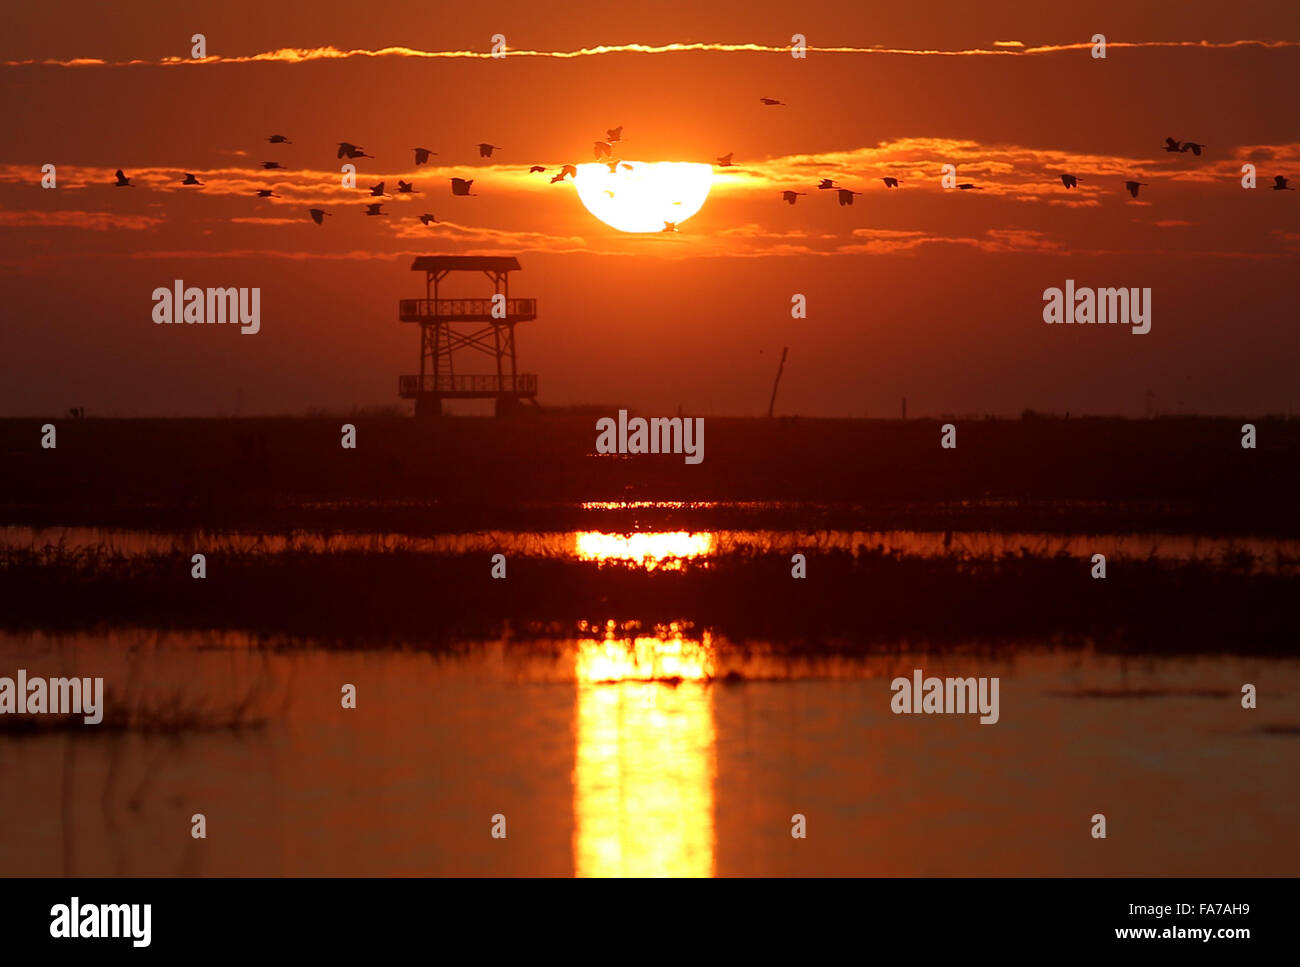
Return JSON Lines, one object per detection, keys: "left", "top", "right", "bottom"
{"left": 573, "top": 161, "right": 714, "bottom": 231}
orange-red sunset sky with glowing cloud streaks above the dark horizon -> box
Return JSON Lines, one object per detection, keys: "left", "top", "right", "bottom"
{"left": 0, "top": 0, "right": 1300, "bottom": 416}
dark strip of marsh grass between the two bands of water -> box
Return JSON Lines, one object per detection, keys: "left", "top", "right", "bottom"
{"left": 0, "top": 545, "right": 1300, "bottom": 652}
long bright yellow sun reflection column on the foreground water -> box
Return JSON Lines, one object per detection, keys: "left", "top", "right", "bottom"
{"left": 573, "top": 629, "right": 718, "bottom": 876}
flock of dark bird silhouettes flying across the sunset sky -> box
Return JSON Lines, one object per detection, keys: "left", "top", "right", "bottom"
{"left": 116, "top": 97, "right": 1295, "bottom": 231}
